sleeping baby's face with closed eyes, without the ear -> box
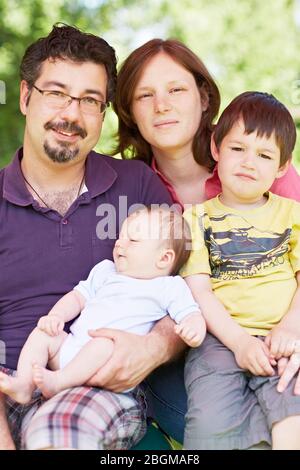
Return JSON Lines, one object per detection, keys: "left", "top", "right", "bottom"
{"left": 113, "top": 211, "right": 168, "bottom": 279}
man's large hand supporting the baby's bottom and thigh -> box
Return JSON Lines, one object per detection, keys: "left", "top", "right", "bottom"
{"left": 88, "top": 328, "right": 166, "bottom": 392}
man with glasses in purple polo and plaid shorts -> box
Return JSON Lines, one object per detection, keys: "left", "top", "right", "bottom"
{"left": 0, "top": 25, "right": 181, "bottom": 449}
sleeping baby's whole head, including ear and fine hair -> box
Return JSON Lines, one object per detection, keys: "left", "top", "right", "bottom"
{"left": 113, "top": 208, "right": 191, "bottom": 279}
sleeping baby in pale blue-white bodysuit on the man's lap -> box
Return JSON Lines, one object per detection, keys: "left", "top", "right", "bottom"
{"left": 0, "top": 209, "right": 206, "bottom": 403}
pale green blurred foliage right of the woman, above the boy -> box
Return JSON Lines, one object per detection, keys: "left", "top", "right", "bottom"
{"left": 164, "top": 0, "right": 300, "bottom": 165}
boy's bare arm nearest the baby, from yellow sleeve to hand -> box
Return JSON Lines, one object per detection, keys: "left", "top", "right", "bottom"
{"left": 185, "top": 274, "right": 274, "bottom": 376}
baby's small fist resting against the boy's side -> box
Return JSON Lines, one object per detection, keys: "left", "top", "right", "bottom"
{"left": 174, "top": 312, "right": 206, "bottom": 348}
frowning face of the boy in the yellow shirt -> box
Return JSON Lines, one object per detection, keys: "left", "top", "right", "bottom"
{"left": 217, "top": 120, "right": 281, "bottom": 203}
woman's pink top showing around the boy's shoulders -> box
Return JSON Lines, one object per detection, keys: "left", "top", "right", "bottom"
{"left": 151, "top": 158, "right": 300, "bottom": 209}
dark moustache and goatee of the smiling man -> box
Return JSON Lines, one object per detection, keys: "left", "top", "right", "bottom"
{"left": 44, "top": 121, "right": 87, "bottom": 163}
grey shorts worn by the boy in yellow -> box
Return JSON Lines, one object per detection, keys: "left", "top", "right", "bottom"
{"left": 184, "top": 334, "right": 300, "bottom": 449}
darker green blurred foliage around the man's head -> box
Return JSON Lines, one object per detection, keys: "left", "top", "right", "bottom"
{"left": 0, "top": 0, "right": 141, "bottom": 168}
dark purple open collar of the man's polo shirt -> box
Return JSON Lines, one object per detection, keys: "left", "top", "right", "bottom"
{"left": 3, "top": 148, "right": 117, "bottom": 206}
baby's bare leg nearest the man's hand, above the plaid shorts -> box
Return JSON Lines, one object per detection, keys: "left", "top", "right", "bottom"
{"left": 33, "top": 338, "right": 113, "bottom": 398}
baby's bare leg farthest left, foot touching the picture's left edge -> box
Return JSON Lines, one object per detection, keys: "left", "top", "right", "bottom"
{"left": 0, "top": 328, "right": 67, "bottom": 403}
